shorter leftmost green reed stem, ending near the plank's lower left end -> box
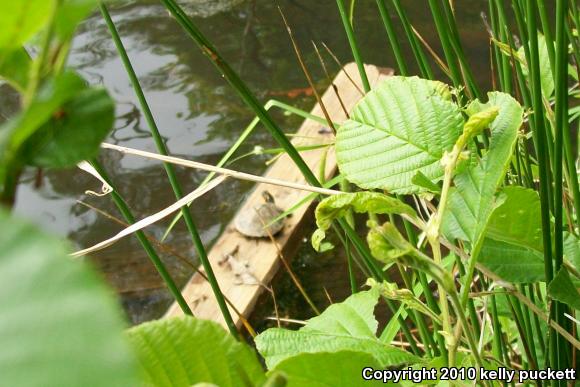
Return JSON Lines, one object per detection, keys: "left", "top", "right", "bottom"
{"left": 91, "top": 159, "right": 193, "bottom": 316}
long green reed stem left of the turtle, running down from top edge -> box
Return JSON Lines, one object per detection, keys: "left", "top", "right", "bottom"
{"left": 100, "top": 3, "right": 239, "bottom": 338}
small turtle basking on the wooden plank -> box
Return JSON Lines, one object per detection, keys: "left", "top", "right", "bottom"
{"left": 234, "top": 191, "right": 284, "bottom": 238}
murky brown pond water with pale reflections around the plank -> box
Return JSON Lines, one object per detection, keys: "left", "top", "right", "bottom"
{"left": 0, "top": 0, "right": 489, "bottom": 323}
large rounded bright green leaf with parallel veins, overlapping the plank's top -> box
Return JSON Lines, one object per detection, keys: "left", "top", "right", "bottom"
{"left": 336, "top": 77, "right": 463, "bottom": 194}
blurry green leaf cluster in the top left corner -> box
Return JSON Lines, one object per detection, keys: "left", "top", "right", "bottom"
{"left": 0, "top": 0, "right": 115, "bottom": 205}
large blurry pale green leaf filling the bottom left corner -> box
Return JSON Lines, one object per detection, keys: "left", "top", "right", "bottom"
{"left": 0, "top": 212, "right": 139, "bottom": 386}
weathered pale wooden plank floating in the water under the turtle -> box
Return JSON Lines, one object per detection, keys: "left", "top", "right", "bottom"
{"left": 166, "top": 63, "right": 392, "bottom": 327}
